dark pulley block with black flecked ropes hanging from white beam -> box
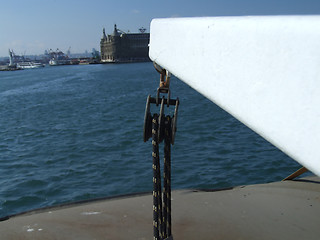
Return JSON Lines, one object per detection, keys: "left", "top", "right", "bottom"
{"left": 143, "top": 64, "right": 179, "bottom": 240}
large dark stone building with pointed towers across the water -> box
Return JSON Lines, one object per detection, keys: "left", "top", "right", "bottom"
{"left": 100, "top": 25, "right": 150, "bottom": 62}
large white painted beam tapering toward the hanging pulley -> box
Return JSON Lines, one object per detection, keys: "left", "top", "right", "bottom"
{"left": 149, "top": 16, "right": 320, "bottom": 176}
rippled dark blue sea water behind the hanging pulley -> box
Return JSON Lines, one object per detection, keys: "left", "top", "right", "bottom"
{"left": 0, "top": 63, "right": 299, "bottom": 217}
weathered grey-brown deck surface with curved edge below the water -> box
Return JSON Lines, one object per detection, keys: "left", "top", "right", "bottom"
{"left": 0, "top": 177, "right": 320, "bottom": 240}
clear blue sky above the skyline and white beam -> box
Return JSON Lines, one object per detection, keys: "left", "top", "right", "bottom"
{"left": 0, "top": 0, "right": 320, "bottom": 56}
